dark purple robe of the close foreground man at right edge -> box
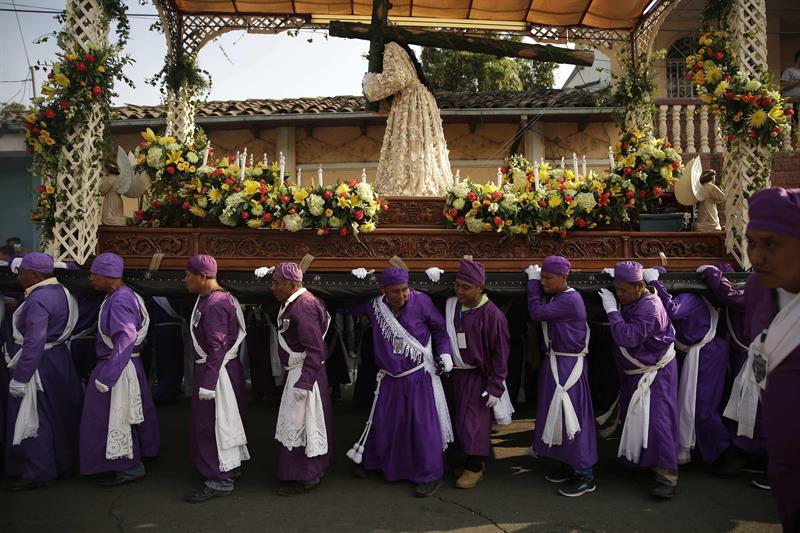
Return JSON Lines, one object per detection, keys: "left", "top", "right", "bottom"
{"left": 745, "top": 274, "right": 800, "bottom": 533}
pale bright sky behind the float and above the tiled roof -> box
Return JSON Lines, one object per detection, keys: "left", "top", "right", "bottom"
{"left": 0, "top": 0, "right": 572, "bottom": 105}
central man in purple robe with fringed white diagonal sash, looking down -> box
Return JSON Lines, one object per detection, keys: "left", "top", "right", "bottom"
{"left": 347, "top": 267, "right": 453, "bottom": 497}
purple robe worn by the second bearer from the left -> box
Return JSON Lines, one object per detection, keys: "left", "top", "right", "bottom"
{"left": 80, "top": 285, "right": 161, "bottom": 476}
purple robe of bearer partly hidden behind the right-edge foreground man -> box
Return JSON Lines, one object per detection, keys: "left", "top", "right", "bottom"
{"left": 703, "top": 268, "right": 767, "bottom": 455}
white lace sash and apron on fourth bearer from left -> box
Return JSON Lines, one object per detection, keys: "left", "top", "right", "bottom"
{"left": 275, "top": 287, "right": 331, "bottom": 457}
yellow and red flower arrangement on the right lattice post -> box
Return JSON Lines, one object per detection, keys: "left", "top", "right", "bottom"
{"left": 686, "top": 29, "right": 794, "bottom": 151}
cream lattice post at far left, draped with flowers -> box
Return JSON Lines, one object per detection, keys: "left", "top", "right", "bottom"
{"left": 50, "top": 0, "right": 108, "bottom": 263}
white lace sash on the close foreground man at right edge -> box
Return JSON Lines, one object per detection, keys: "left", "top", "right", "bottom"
{"left": 723, "top": 294, "right": 800, "bottom": 439}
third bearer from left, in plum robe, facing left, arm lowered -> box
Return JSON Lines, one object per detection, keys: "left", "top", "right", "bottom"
{"left": 185, "top": 255, "right": 250, "bottom": 503}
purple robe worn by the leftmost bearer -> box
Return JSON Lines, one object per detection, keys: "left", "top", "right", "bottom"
{"left": 6, "top": 285, "right": 83, "bottom": 481}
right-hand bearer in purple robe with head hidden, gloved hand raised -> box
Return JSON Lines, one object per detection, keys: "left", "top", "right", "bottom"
{"left": 643, "top": 268, "right": 731, "bottom": 464}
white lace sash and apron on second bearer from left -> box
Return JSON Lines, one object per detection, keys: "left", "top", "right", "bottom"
{"left": 97, "top": 292, "right": 150, "bottom": 460}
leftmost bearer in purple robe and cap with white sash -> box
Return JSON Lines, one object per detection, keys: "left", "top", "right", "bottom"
{"left": 6, "top": 253, "right": 83, "bottom": 490}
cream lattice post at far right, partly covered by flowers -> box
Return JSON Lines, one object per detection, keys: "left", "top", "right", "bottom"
{"left": 722, "top": 0, "right": 772, "bottom": 268}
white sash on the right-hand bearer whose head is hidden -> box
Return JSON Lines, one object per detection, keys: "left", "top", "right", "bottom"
{"left": 675, "top": 298, "right": 719, "bottom": 464}
